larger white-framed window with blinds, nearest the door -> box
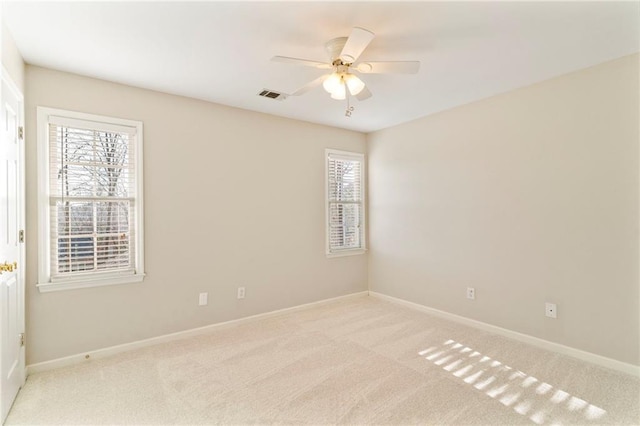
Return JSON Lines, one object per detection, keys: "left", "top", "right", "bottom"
{"left": 38, "top": 107, "right": 144, "bottom": 291}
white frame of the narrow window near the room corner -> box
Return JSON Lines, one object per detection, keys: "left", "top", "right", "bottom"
{"left": 324, "top": 148, "right": 367, "bottom": 258}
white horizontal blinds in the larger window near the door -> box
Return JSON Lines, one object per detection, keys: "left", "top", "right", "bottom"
{"left": 49, "top": 118, "right": 136, "bottom": 280}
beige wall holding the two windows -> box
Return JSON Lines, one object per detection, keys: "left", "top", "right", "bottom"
{"left": 26, "top": 66, "right": 367, "bottom": 364}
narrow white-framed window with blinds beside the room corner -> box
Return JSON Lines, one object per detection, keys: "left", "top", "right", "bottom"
{"left": 326, "top": 149, "right": 365, "bottom": 256}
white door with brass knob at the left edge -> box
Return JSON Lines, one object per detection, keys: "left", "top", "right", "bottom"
{"left": 0, "top": 70, "right": 25, "bottom": 423}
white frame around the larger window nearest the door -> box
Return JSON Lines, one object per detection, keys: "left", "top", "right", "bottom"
{"left": 36, "top": 106, "right": 145, "bottom": 292}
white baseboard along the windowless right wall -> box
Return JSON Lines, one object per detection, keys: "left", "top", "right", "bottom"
{"left": 369, "top": 291, "right": 640, "bottom": 377}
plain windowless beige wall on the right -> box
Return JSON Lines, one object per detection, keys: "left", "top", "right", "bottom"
{"left": 368, "top": 55, "right": 640, "bottom": 365}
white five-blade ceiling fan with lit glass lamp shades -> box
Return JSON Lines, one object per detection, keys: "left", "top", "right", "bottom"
{"left": 271, "top": 27, "right": 420, "bottom": 103}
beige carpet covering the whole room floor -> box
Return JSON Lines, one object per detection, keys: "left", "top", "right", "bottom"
{"left": 6, "top": 296, "right": 640, "bottom": 425}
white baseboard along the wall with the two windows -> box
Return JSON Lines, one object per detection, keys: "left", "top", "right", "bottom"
{"left": 26, "top": 291, "right": 369, "bottom": 376}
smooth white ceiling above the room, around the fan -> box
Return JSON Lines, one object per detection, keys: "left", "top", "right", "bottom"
{"left": 2, "top": 1, "right": 640, "bottom": 132}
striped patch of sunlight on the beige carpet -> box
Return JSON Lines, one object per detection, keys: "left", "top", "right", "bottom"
{"left": 418, "top": 340, "right": 607, "bottom": 424}
